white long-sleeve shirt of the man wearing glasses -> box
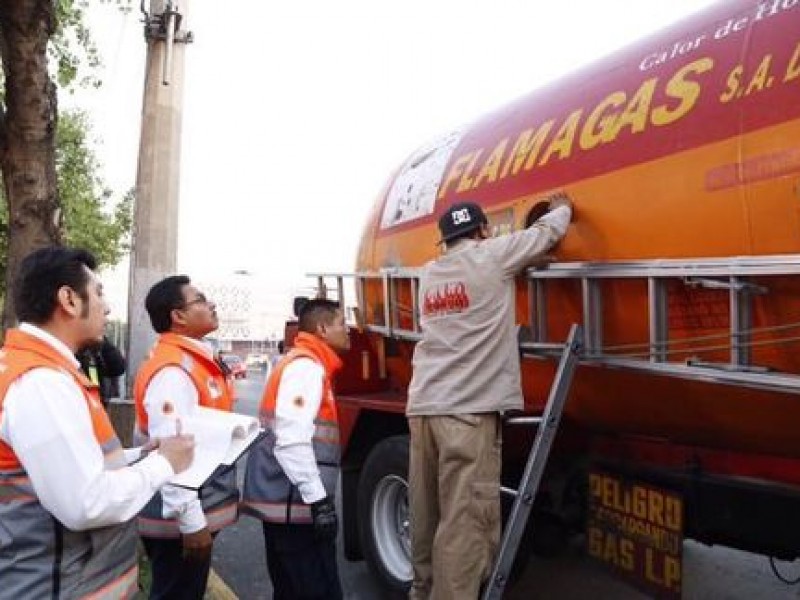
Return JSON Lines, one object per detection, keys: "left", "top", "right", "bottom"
{"left": 144, "top": 338, "right": 213, "bottom": 533}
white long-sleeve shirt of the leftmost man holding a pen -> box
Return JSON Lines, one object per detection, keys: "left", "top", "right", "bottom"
{"left": 0, "top": 323, "right": 174, "bottom": 531}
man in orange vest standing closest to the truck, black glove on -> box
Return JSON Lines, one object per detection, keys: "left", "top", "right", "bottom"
{"left": 242, "top": 299, "right": 350, "bottom": 600}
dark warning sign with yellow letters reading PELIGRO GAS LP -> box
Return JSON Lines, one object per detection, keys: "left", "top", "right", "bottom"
{"left": 586, "top": 472, "right": 683, "bottom": 599}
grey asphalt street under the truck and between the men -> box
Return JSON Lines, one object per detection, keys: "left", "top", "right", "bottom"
{"left": 213, "top": 371, "right": 800, "bottom": 600}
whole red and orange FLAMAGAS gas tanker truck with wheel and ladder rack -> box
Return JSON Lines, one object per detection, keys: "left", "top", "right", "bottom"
{"left": 310, "top": 0, "right": 800, "bottom": 596}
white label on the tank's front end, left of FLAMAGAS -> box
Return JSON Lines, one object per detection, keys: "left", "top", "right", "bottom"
{"left": 381, "top": 131, "right": 462, "bottom": 229}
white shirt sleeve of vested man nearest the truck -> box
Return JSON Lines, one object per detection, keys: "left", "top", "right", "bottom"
{"left": 274, "top": 358, "right": 327, "bottom": 504}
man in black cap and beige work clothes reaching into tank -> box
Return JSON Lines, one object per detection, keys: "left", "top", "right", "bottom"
{"left": 406, "top": 195, "right": 572, "bottom": 600}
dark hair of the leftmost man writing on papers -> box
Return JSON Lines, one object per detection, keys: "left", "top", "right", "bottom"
{"left": 12, "top": 246, "right": 97, "bottom": 325}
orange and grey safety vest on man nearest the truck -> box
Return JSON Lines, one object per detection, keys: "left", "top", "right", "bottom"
{"left": 242, "top": 332, "right": 342, "bottom": 523}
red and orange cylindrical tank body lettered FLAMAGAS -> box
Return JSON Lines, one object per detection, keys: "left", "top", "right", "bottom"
{"left": 357, "top": 0, "right": 800, "bottom": 460}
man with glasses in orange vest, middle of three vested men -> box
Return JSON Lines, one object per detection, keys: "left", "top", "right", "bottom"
{"left": 134, "top": 275, "right": 239, "bottom": 600}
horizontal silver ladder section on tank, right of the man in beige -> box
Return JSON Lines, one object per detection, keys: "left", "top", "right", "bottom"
{"left": 520, "top": 255, "right": 800, "bottom": 394}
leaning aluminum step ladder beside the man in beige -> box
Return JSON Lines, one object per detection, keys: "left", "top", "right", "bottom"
{"left": 483, "top": 325, "right": 583, "bottom": 600}
